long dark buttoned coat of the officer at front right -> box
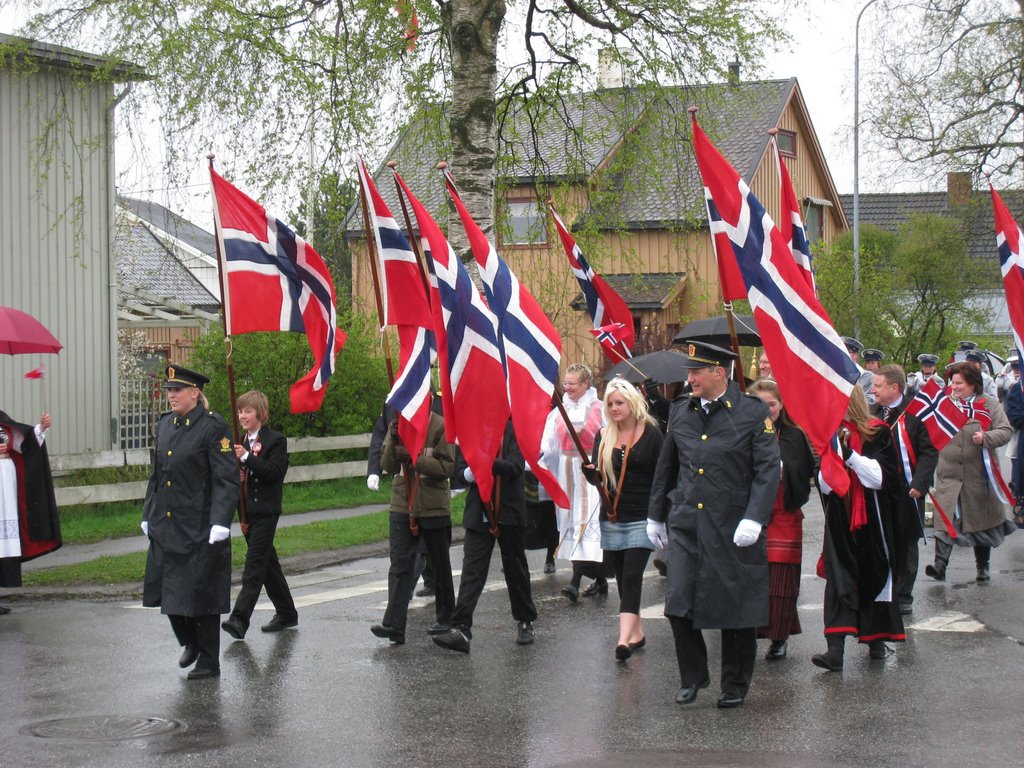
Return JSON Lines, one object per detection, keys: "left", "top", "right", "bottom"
{"left": 649, "top": 383, "right": 780, "bottom": 629}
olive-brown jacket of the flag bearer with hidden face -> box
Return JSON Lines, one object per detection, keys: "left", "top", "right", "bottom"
{"left": 381, "top": 413, "right": 455, "bottom": 517}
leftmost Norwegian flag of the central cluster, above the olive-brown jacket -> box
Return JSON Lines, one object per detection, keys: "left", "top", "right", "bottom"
{"left": 355, "top": 157, "right": 436, "bottom": 456}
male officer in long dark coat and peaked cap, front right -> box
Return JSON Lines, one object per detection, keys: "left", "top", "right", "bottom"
{"left": 647, "top": 342, "right": 780, "bottom": 709}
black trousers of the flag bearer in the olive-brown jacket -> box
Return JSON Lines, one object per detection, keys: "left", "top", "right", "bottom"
{"left": 384, "top": 512, "right": 455, "bottom": 632}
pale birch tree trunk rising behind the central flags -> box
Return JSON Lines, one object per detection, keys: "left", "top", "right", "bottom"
{"left": 445, "top": 0, "right": 505, "bottom": 261}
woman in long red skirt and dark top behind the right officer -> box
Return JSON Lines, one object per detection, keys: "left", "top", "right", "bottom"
{"left": 750, "top": 379, "right": 814, "bottom": 662}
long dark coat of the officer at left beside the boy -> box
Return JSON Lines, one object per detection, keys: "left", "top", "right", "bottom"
{"left": 142, "top": 407, "right": 239, "bottom": 616}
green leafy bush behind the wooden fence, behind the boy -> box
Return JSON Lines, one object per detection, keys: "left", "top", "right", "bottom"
{"left": 190, "top": 315, "right": 388, "bottom": 437}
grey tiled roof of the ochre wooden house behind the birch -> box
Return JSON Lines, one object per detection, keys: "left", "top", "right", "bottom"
{"left": 345, "top": 78, "right": 811, "bottom": 238}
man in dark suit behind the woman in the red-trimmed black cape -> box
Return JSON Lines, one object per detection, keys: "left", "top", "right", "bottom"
{"left": 871, "top": 366, "right": 939, "bottom": 614}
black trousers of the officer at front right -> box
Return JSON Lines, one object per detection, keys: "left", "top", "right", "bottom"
{"left": 669, "top": 616, "right": 758, "bottom": 697}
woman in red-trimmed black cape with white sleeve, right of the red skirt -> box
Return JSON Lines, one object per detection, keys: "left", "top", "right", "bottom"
{"left": 811, "top": 387, "right": 906, "bottom": 672}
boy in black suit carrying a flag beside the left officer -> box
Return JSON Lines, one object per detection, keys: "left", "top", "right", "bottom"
{"left": 220, "top": 390, "right": 299, "bottom": 640}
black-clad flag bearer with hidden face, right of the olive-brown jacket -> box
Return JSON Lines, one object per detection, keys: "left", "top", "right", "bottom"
{"left": 434, "top": 421, "right": 537, "bottom": 653}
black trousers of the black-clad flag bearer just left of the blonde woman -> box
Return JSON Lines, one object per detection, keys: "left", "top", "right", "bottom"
{"left": 452, "top": 523, "right": 537, "bottom": 637}
